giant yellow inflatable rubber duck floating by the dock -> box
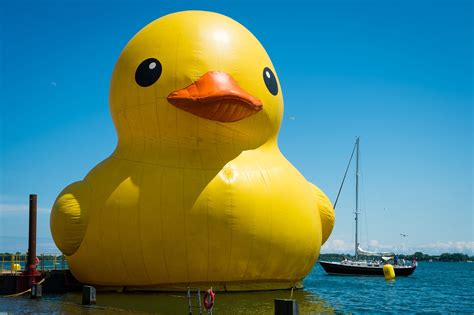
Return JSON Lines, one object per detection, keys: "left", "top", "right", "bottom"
{"left": 51, "top": 11, "right": 334, "bottom": 291}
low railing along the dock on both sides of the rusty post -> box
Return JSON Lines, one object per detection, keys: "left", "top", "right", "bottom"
{"left": 0, "top": 253, "right": 69, "bottom": 273}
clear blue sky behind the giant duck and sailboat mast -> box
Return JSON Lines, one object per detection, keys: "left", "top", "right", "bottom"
{"left": 0, "top": 0, "right": 474, "bottom": 253}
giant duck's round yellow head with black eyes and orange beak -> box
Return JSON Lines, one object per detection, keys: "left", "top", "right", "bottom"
{"left": 110, "top": 11, "right": 283, "bottom": 155}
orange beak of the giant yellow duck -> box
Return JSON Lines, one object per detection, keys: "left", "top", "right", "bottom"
{"left": 168, "top": 71, "right": 263, "bottom": 122}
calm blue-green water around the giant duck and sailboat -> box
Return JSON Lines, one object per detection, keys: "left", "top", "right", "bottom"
{"left": 0, "top": 262, "right": 474, "bottom": 314}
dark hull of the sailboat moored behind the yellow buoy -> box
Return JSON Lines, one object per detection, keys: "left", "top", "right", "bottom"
{"left": 319, "top": 261, "right": 416, "bottom": 277}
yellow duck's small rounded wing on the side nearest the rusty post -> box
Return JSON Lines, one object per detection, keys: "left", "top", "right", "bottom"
{"left": 50, "top": 181, "right": 91, "bottom": 255}
